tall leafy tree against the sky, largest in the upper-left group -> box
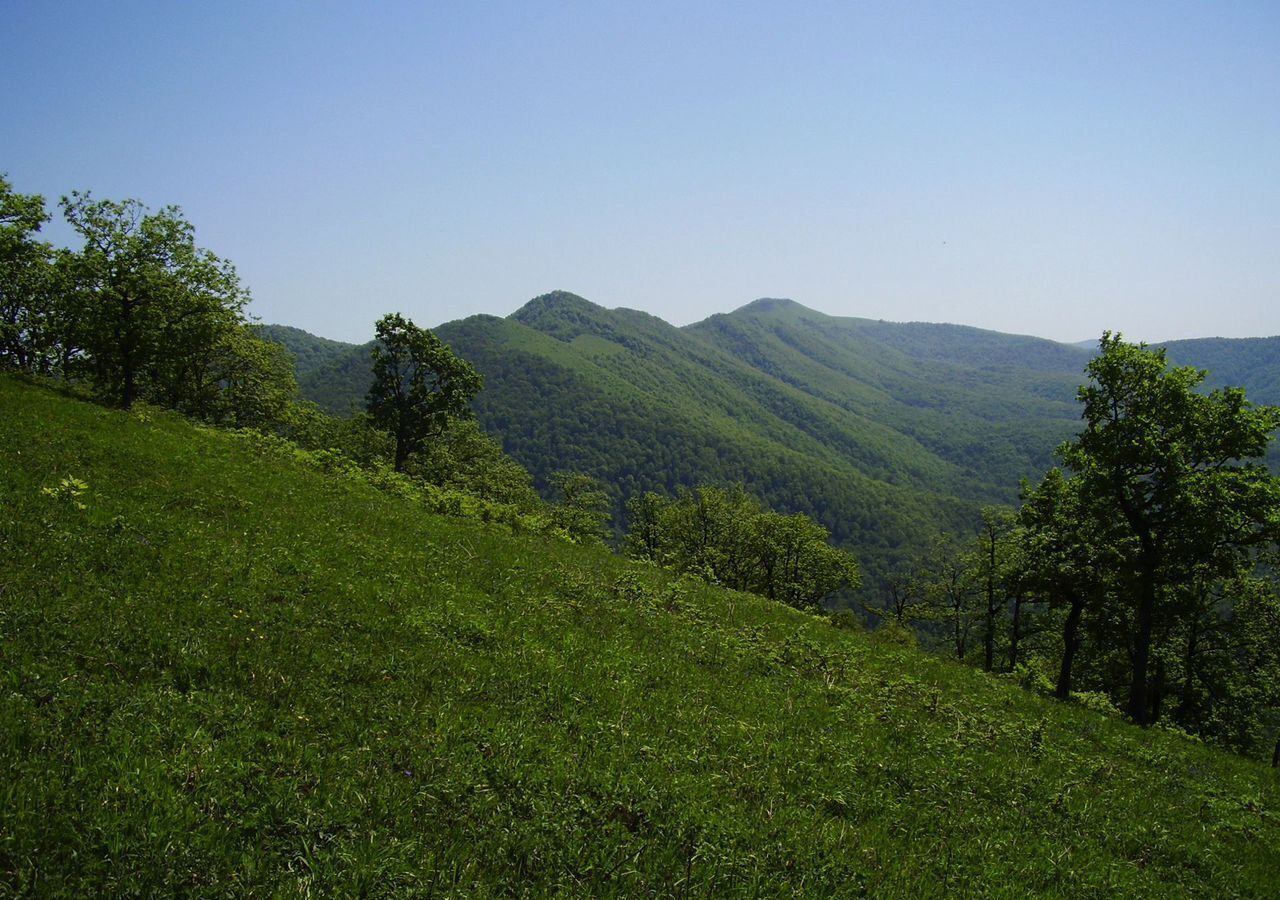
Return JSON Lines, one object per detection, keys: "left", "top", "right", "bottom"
{"left": 61, "top": 197, "right": 248, "bottom": 408}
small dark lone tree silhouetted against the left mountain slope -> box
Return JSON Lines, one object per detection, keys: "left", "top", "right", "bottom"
{"left": 367, "top": 312, "right": 484, "bottom": 471}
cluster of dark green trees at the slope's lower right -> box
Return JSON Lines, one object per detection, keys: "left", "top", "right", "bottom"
{"left": 873, "top": 334, "right": 1280, "bottom": 762}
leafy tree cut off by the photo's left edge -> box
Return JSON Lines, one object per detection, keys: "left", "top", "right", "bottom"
{"left": 0, "top": 175, "right": 56, "bottom": 370}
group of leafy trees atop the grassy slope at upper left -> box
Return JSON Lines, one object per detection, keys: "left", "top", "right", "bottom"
{"left": 0, "top": 178, "right": 297, "bottom": 426}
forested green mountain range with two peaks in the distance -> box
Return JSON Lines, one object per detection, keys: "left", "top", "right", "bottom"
{"left": 262, "top": 299, "right": 1280, "bottom": 583}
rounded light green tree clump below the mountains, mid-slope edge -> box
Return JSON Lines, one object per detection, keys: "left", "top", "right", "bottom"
{"left": 626, "top": 485, "right": 860, "bottom": 608}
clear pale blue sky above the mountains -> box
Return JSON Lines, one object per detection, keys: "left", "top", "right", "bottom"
{"left": 0, "top": 0, "right": 1280, "bottom": 341}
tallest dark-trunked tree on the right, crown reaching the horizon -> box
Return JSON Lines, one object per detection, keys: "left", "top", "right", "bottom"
{"left": 1059, "top": 333, "right": 1280, "bottom": 725}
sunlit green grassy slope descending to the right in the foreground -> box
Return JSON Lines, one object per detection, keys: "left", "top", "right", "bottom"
{"left": 0, "top": 378, "right": 1280, "bottom": 896}
